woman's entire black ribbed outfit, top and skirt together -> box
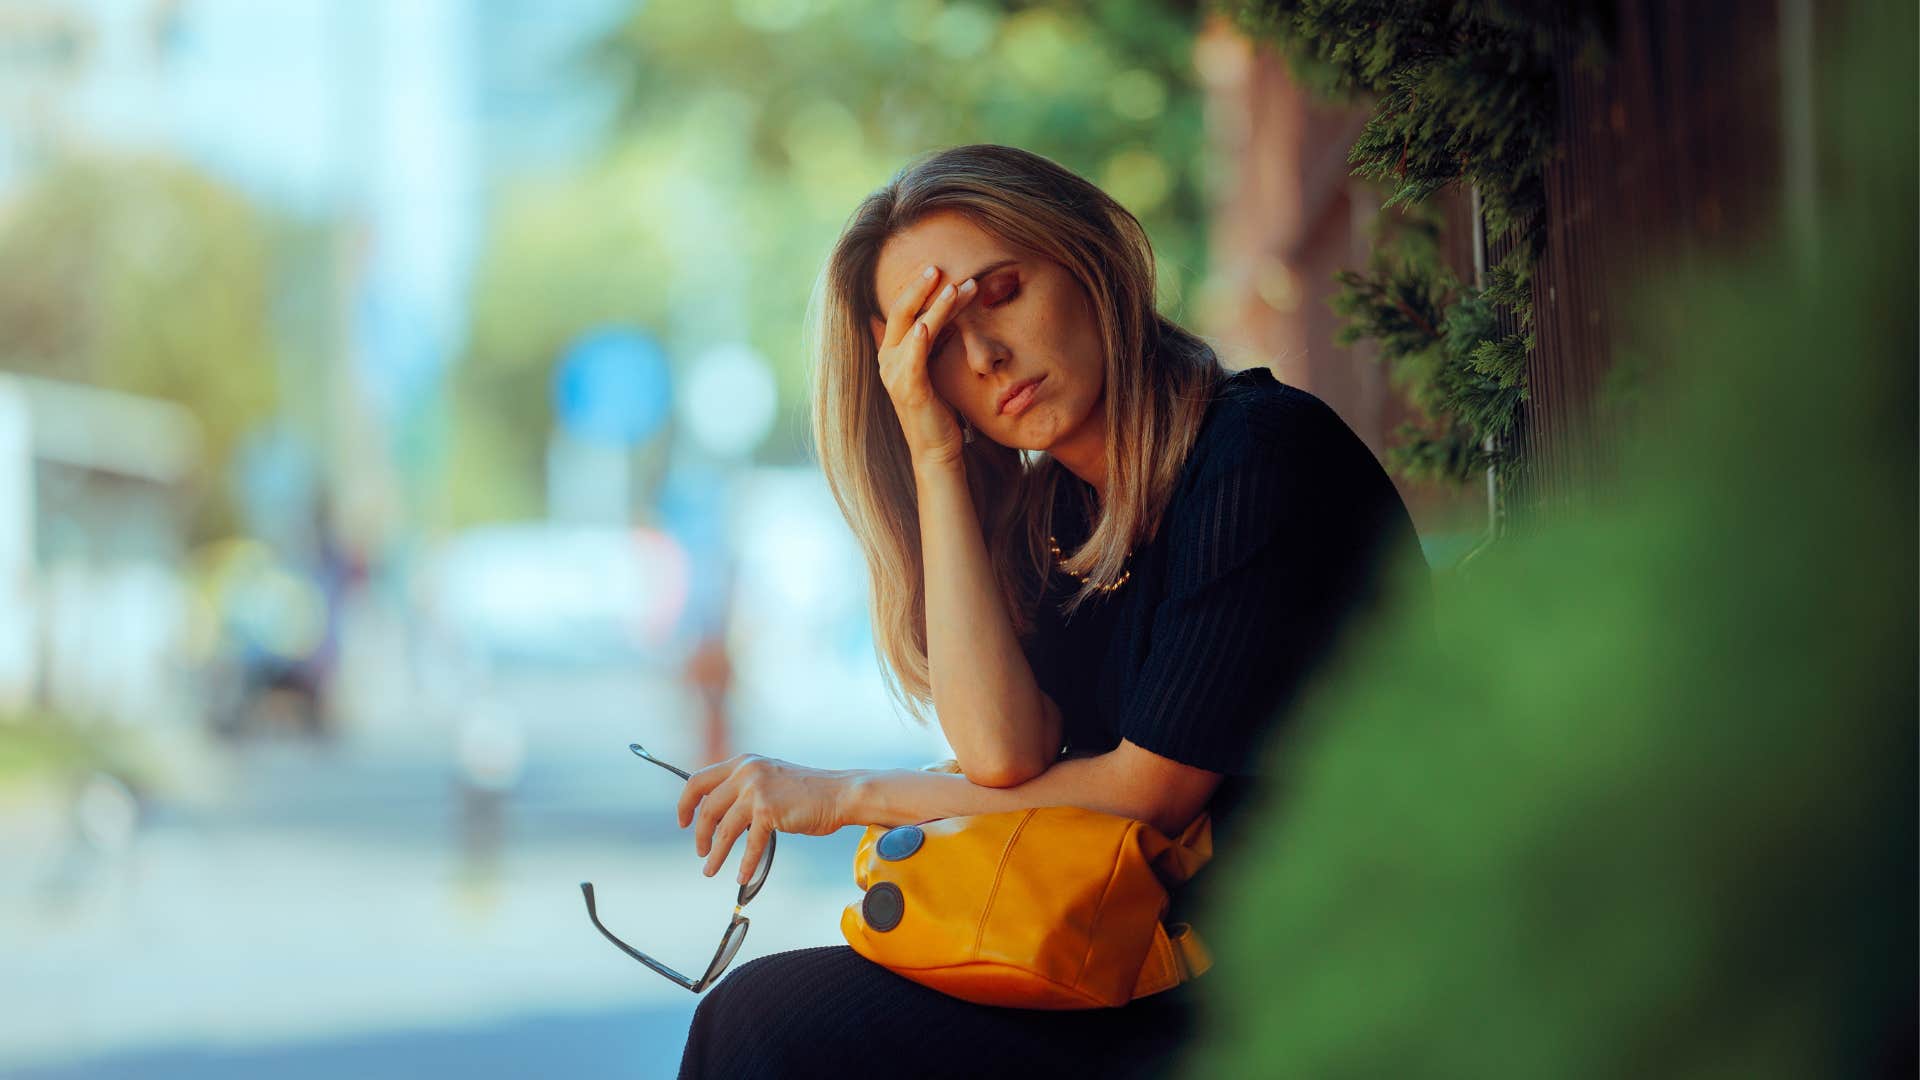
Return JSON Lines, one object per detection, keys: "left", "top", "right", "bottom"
{"left": 680, "top": 369, "right": 1425, "bottom": 1080}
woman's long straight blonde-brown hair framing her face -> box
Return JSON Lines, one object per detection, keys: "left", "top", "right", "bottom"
{"left": 808, "top": 144, "right": 1225, "bottom": 719}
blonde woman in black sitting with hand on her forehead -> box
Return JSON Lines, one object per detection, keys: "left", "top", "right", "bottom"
{"left": 680, "top": 146, "right": 1425, "bottom": 1076}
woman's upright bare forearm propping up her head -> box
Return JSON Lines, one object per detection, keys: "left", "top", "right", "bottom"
{"left": 914, "top": 461, "right": 1060, "bottom": 786}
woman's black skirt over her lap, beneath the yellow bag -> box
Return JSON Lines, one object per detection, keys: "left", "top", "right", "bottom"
{"left": 680, "top": 945, "right": 1198, "bottom": 1080}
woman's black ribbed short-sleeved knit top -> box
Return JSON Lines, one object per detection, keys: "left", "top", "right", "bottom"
{"left": 1023, "top": 367, "right": 1427, "bottom": 857}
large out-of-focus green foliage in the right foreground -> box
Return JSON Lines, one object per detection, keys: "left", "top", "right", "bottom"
{"left": 1188, "top": 4, "right": 1920, "bottom": 1078}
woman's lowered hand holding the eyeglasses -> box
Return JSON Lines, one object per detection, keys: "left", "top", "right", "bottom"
{"left": 678, "top": 753, "right": 849, "bottom": 882}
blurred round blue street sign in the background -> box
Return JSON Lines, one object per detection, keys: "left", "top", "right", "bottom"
{"left": 553, "top": 329, "right": 674, "bottom": 446}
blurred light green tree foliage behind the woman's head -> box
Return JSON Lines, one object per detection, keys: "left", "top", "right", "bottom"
{"left": 453, "top": 0, "right": 1208, "bottom": 521}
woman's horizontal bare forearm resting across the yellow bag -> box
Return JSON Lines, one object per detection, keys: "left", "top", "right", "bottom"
{"left": 839, "top": 753, "right": 1206, "bottom": 836}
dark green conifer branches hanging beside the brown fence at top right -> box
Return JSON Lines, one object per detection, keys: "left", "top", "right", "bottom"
{"left": 1229, "top": 0, "right": 1611, "bottom": 482}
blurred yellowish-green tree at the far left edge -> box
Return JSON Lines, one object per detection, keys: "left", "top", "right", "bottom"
{"left": 0, "top": 158, "right": 276, "bottom": 536}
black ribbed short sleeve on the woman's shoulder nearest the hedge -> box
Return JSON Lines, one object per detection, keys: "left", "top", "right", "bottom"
{"left": 1119, "top": 459, "right": 1338, "bottom": 774}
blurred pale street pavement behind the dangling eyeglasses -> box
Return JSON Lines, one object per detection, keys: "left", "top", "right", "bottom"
{"left": 0, "top": 664, "right": 952, "bottom": 1078}
